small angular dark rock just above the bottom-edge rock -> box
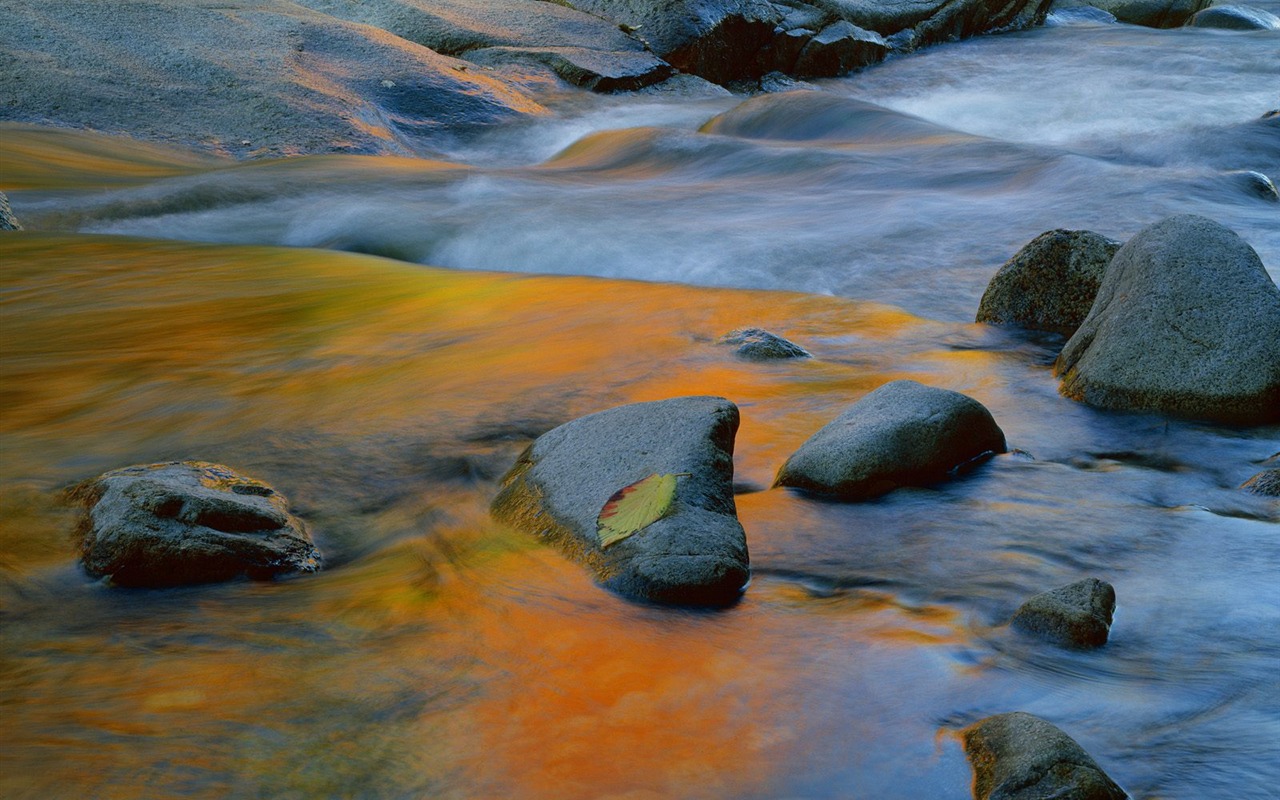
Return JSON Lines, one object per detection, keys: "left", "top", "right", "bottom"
{"left": 1012, "top": 577, "right": 1116, "bottom": 648}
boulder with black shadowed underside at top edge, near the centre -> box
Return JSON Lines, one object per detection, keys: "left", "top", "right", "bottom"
{"left": 567, "top": 0, "right": 783, "bottom": 83}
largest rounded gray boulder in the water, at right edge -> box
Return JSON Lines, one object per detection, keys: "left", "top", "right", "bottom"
{"left": 1055, "top": 215, "right": 1280, "bottom": 425}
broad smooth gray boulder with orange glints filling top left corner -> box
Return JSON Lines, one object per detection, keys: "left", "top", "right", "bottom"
{"left": 0, "top": 0, "right": 547, "bottom": 157}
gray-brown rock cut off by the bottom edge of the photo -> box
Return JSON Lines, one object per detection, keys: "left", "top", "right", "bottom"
{"left": 961, "top": 712, "right": 1129, "bottom": 800}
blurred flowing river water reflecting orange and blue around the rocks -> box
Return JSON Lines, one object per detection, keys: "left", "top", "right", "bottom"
{"left": 0, "top": 18, "right": 1280, "bottom": 800}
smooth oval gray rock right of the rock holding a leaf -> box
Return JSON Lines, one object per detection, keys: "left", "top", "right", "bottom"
{"left": 774, "top": 380, "right": 1005, "bottom": 500}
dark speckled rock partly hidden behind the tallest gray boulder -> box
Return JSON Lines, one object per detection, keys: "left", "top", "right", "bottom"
{"left": 977, "top": 230, "right": 1120, "bottom": 335}
